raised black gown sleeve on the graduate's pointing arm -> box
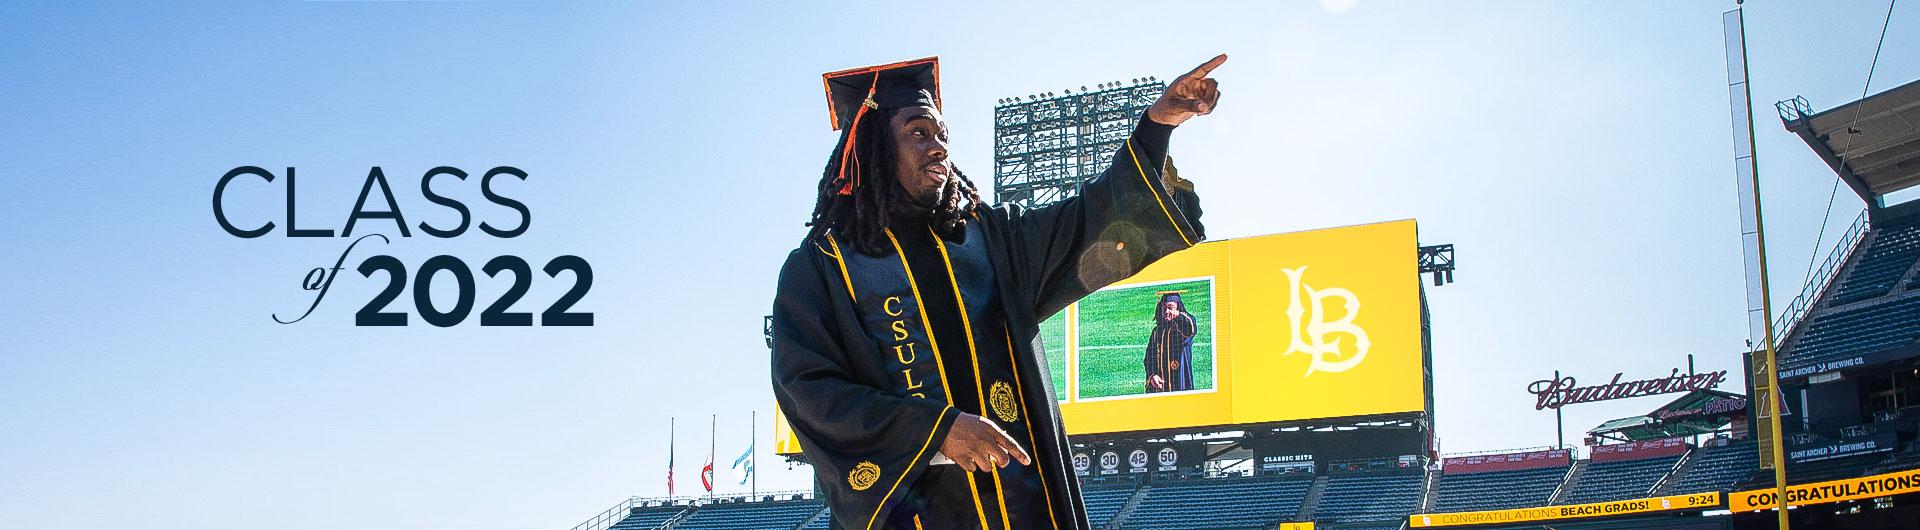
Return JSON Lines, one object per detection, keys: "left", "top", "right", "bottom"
{"left": 996, "top": 115, "right": 1206, "bottom": 319}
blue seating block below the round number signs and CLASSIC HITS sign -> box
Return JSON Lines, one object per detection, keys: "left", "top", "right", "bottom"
{"left": 1121, "top": 476, "right": 1313, "bottom": 530}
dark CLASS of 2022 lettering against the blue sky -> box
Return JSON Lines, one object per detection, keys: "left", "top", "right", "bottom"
{"left": 213, "top": 165, "right": 593, "bottom": 326}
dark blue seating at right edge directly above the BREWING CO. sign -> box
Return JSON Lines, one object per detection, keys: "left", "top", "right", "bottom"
{"left": 1780, "top": 296, "right": 1920, "bottom": 371}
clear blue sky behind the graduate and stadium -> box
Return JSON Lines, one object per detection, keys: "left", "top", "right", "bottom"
{"left": 0, "top": 2, "right": 1920, "bottom": 528}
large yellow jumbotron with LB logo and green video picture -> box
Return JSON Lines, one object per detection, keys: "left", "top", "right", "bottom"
{"left": 774, "top": 219, "right": 1427, "bottom": 453}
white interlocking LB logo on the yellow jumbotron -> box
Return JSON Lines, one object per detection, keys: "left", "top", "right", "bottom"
{"left": 1281, "top": 265, "right": 1373, "bottom": 376}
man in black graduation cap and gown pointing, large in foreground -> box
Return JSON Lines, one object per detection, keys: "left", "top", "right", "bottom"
{"left": 772, "top": 56, "right": 1227, "bottom": 530}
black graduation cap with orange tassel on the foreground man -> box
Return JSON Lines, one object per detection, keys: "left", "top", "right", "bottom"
{"left": 820, "top": 58, "right": 941, "bottom": 196}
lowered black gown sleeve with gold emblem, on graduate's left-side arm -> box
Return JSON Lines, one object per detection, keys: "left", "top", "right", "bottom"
{"left": 772, "top": 244, "right": 960, "bottom": 528}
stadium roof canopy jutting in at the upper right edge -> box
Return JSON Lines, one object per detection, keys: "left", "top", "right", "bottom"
{"left": 1774, "top": 81, "right": 1920, "bottom": 207}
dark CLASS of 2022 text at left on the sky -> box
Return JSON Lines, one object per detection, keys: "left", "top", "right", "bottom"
{"left": 213, "top": 165, "right": 593, "bottom": 326}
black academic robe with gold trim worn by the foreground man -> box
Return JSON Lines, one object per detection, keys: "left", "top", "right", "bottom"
{"left": 772, "top": 119, "right": 1204, "bottom": 530}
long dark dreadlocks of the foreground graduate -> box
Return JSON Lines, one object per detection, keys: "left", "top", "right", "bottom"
{"left": 806, "top": 109, "right": 981, "bottom": 255}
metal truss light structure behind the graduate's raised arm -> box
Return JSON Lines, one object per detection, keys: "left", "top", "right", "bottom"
{"left": 993, "top": 77, "right": 1167, "bottom": 207}
